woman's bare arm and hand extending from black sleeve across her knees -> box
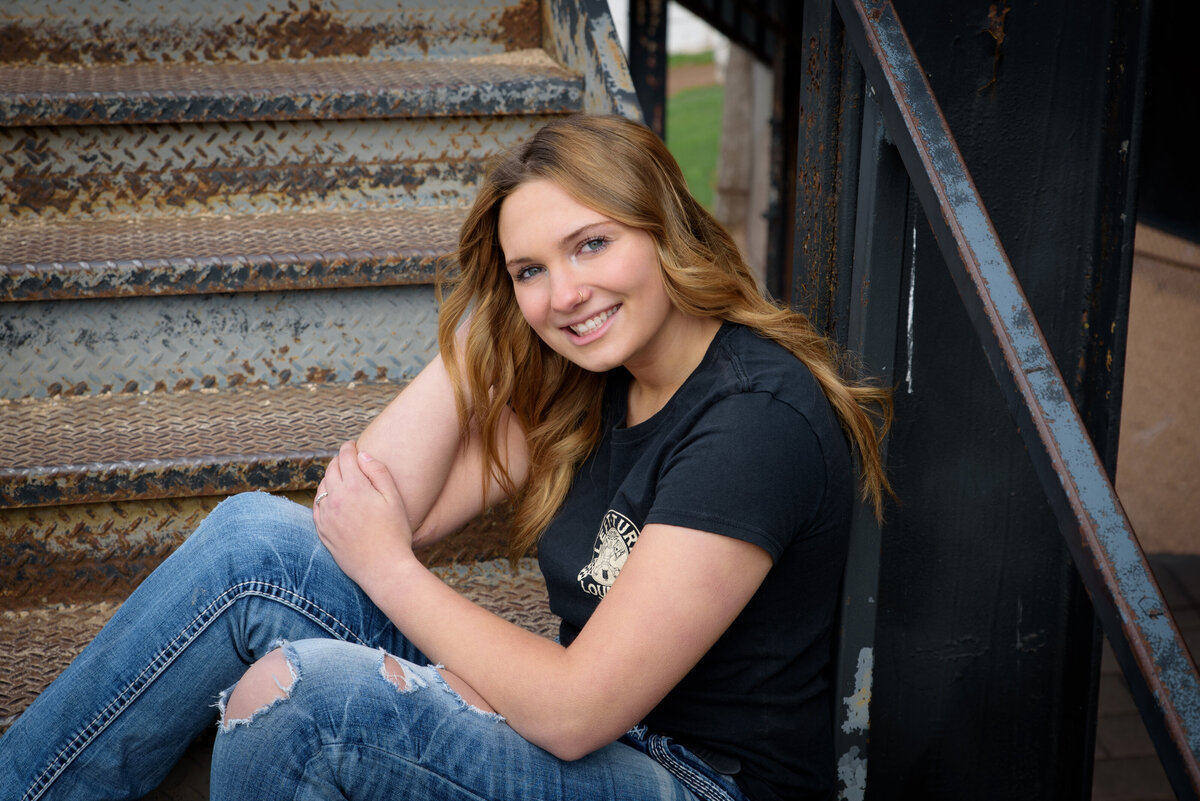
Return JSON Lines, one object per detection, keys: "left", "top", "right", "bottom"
{"left": 318, "top": 444, "right": 772, "bottom": 759}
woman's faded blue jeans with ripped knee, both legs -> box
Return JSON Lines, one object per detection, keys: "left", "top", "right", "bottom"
{"left": 0, "top": 494, "right": 744, "bottom": 801}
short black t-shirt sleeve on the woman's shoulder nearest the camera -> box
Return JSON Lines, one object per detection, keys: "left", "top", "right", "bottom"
{"left": 646, "top": 392, "right": 827, "bottom": 560}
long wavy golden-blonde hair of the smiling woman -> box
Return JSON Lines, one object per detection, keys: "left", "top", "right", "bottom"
{"left": 438, "top": 115, "right": 892, "bottom": 558}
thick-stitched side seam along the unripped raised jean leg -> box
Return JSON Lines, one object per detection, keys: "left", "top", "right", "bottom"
{"left": 22, "top": 579, "right": 366, "bottom": 801}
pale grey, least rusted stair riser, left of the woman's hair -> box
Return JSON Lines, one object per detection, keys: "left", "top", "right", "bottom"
{"left": 0, "top": 285, "right": 437, "bottom": 398}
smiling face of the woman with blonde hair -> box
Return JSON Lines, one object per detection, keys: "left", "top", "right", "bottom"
{"left": 499, "top": 180, "right": 694, "bottom": 378}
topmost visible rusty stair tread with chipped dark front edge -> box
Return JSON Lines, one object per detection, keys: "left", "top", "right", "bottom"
{"left": 0, "top": 49, "right": 583, "bottom": 126}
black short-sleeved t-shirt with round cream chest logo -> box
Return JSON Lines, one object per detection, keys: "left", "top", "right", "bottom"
{"left": 538, "top": 323, "right": 853, "bottom": 801}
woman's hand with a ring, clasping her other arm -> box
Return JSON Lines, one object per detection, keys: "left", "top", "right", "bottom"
{"left": 312, "top": 441, "right": 413, "bottom": 595}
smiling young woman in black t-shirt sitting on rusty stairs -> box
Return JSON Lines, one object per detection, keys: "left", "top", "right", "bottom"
{"left": 0, "top": 116, "right": 890, "bottom": 801}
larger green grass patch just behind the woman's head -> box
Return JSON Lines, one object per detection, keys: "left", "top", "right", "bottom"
{"left": 666, "top": 86, "right": 725, "bottom": 210}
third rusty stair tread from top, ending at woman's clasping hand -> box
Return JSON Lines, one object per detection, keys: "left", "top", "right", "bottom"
{"left": 0, "top": 384, "right": 400, "bottom": 508}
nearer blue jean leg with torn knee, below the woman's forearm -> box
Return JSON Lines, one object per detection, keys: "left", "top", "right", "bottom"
{"left": 211, "top": 640, "right": 695, "bottom": 801}
